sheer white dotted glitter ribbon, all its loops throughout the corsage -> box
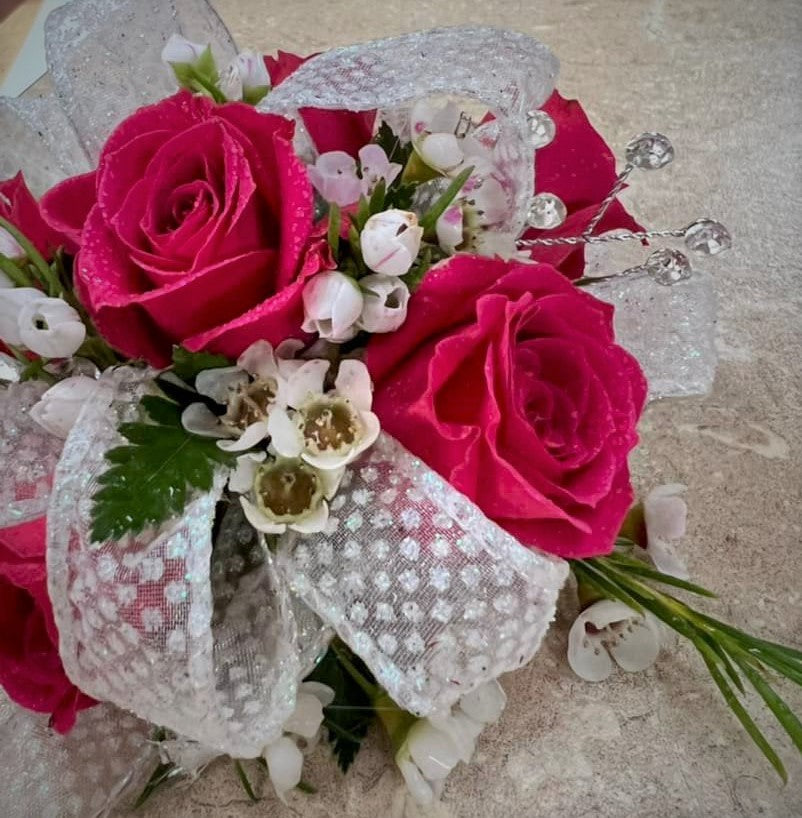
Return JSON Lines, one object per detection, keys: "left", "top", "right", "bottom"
{"left": 0, "top": 0, "right": 709, "bottom": 818}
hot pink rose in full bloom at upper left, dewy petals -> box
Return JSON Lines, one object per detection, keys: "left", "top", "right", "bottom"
{"left": 42, "top": 91, "right": 331, "bottom": 366}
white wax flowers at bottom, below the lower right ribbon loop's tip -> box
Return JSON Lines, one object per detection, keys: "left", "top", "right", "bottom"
{"left": 395, "top": 680, "right": 507, "bottom": 805}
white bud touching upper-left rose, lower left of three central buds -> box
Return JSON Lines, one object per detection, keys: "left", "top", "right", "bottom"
{"left": 302, "top": 270, "right": 362, "bottom": 343}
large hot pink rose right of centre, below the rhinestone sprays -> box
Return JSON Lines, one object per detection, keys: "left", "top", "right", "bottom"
{"left": 367, "top": 256, "right": 646, "bottom": 557}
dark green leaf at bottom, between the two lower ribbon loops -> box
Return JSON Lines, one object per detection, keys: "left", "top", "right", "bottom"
{"left": 307, "top": 640, "right": 376, "bottom": 772}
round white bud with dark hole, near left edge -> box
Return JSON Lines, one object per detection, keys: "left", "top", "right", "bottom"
{"left": 17, "top": 293, "right": 86, "bottom": 358}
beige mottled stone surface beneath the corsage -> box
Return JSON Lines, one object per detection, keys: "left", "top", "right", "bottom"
{"left": 125, "top": 0, "right": 802, "bottom": 818}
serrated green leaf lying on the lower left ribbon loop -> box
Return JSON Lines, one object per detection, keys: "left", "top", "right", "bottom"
{"left": 92, "top": 396, "right": 234, "bottom": 542}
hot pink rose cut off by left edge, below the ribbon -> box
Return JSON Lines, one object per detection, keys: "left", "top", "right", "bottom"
{"left": 0, "top": 517, "right": 96, "bottom": 733}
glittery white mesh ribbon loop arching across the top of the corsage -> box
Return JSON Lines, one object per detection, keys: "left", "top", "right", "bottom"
{"left": 259, "top": 27, "right": 559, "bottom": 233}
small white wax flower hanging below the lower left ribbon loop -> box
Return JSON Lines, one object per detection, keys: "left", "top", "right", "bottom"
{"left": 262, "top": 682, "right": 334, "bottom": 803}
